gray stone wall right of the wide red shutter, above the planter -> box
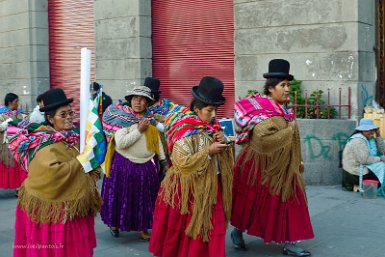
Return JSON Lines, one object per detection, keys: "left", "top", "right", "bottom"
{"left": 234, "top": 0, "right": 376, "bottom": 118}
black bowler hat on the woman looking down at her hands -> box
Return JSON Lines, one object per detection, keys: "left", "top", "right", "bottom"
{"left": 192, "top": 77, "right": 226, "bottom": 106}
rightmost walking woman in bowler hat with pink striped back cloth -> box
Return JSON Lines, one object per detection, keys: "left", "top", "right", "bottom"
{"left": 231, "top": 59, "right": 314, "bottom": 256}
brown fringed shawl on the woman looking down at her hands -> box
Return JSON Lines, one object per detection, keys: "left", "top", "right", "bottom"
{"left": 160, "top": 133, "right": 233, "bottom": 242}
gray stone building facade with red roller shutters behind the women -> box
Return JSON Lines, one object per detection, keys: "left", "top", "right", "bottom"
{"left": 0, "top": 0, "right": 383, "bottom": 184}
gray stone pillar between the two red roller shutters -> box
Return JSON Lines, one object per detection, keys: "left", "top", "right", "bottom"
{"left": 94, "top": 0, "right": 152, "bottom": 100}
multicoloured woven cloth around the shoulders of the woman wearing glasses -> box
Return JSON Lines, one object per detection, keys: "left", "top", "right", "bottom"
{"left": 8, "top": 121, "right": 79, "bottom": 172}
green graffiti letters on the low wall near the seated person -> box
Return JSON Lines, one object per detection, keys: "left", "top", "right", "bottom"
{"left": 303, "top": 132, "right": 349, "bottom": 160}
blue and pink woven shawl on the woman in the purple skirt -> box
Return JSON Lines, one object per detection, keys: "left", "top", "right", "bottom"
{"left": 103, "top": 100, "right": 156, "bottom": 142}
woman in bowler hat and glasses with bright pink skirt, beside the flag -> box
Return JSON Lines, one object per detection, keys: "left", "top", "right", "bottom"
{"left": 10, "top": 88, "right": 101, "bottom": 257}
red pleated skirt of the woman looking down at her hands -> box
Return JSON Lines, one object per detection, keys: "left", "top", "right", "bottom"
{"left": 149, "top": 180, "right": 226, "bottom": 257}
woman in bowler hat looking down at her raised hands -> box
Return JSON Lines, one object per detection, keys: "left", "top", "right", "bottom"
{"left": 149, "top": 77, "right": 233, "bottom": 257}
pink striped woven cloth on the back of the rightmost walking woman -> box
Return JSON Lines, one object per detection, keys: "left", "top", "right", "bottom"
{"left": 234, "top": 94, "right": 294, "bottom": 144}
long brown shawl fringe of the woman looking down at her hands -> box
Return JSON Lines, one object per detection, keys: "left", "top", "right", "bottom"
{"left": 160, "top": 147, "right": 233, "bottom": 242}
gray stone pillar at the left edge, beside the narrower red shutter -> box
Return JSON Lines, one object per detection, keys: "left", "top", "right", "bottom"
{"left": 0, "top": 0, "right": 49, "bottom": 109}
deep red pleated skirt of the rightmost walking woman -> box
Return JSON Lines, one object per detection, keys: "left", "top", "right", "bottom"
{"left": 231, "top": 148, "right": 314, "bottom": 243}
